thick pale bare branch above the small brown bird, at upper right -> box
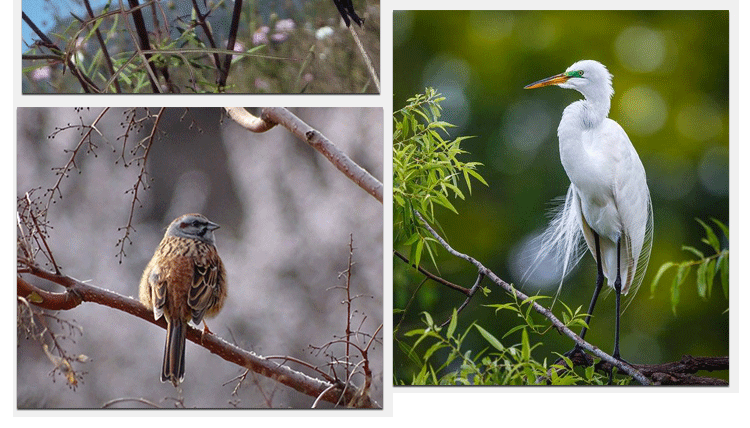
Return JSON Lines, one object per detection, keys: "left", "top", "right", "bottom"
{"left": 225, "top": 107, "right": 383, "bottom": 203}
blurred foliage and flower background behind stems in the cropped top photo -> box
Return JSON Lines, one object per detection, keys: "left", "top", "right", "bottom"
{"left": 22, "top": 0, "right": 380, "bottom": 93}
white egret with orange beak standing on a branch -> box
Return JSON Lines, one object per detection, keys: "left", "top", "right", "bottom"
{"left": 525, "top": 60, "right": 653, "bottom": 372}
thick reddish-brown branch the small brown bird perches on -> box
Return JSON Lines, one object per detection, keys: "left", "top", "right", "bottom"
{"left": 17, "top": 267, "right": 377, "bottom": 408}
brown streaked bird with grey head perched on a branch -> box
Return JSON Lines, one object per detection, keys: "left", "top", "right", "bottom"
{"left": 139, "top": 214, "right": 227, "bottom": 386}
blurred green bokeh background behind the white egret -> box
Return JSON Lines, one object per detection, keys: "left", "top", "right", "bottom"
{"left": 393, "top": 11, "right": 731, "bottom": 383}
